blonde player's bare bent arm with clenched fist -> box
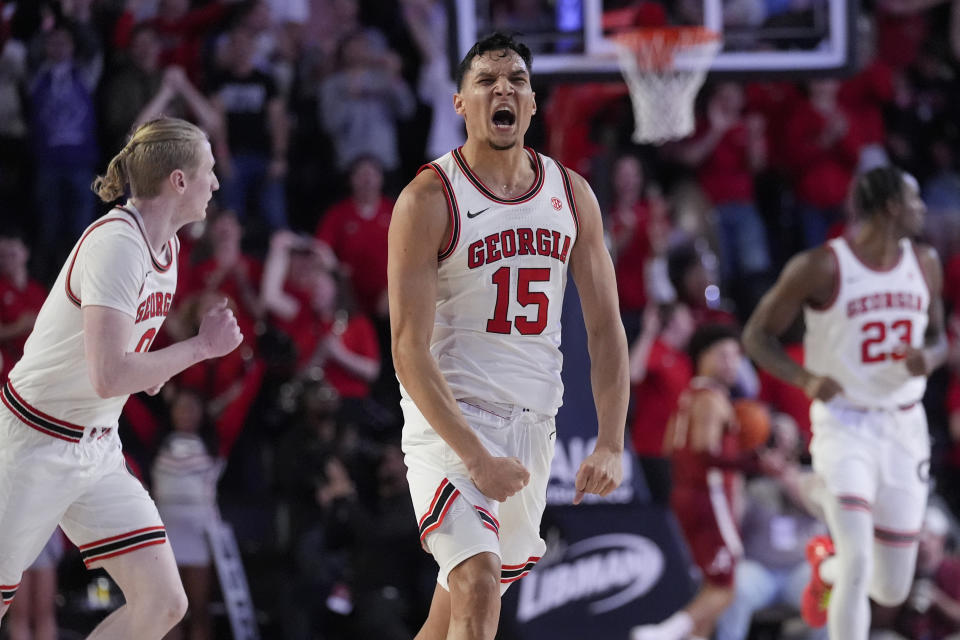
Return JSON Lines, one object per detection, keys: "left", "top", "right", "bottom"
{"left": 83, "top": 300, "right": 243, "bottom": 398}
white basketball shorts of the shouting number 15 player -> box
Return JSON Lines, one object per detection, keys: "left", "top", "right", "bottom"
{"left": 400, "top": 399, "right": 556, "bottom": 593}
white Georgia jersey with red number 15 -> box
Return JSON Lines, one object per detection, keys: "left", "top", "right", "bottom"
{"left": 403, "top": 147, "right": 579, "bottom": 415}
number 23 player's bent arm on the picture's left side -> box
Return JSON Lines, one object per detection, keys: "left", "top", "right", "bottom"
{"left": 743, "top": 247, "right": 843, "bottom": 401}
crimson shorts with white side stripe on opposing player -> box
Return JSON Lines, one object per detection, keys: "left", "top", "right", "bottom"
{"left": 670, "top": 470, "right": 743, "bottom": 587}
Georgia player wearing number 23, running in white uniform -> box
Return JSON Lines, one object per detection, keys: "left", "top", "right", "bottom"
{"left": 744, "top": 167, "right": 947, "bottom": 640}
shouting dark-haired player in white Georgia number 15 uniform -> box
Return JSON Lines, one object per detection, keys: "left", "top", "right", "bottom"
{"left": 388, "top": 34, "right": 629, "bottom": 640}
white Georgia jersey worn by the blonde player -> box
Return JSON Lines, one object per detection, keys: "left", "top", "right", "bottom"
{"left": 3, "top": 203, "right": 179, "bottom": 436}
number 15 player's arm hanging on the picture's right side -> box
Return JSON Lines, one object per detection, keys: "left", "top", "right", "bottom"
{"left": 570, "top": 171, "right": 630, "bottom": 504}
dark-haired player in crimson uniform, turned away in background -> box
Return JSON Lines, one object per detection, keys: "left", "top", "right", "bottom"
{"left": 630, "top": 325, "right": 747, "bottom": 640}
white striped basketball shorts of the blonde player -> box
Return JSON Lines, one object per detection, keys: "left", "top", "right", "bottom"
{"left": 0, "top": 397, "right": 166, "bottom": 604}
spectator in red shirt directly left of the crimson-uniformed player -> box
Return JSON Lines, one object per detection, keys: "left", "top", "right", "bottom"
{"left": 630, "top": 302, "right": 696, "bottom": 505}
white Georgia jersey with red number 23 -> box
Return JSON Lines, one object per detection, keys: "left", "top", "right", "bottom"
{"left": 804, "top": 238, "right": 930, "bottom": 409}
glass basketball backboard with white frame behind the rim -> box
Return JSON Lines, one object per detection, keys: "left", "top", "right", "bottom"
{"left": 448, "top": 0, "right": 857, "bottom": 80}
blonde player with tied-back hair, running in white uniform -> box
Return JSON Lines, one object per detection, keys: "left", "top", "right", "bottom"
{"left": 0, "top": 118, "right": 241, "bottom": 640}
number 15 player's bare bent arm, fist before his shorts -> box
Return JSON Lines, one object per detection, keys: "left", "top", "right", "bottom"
{"left": 387, "top": 171, "right": 530, "bottom": 502}
